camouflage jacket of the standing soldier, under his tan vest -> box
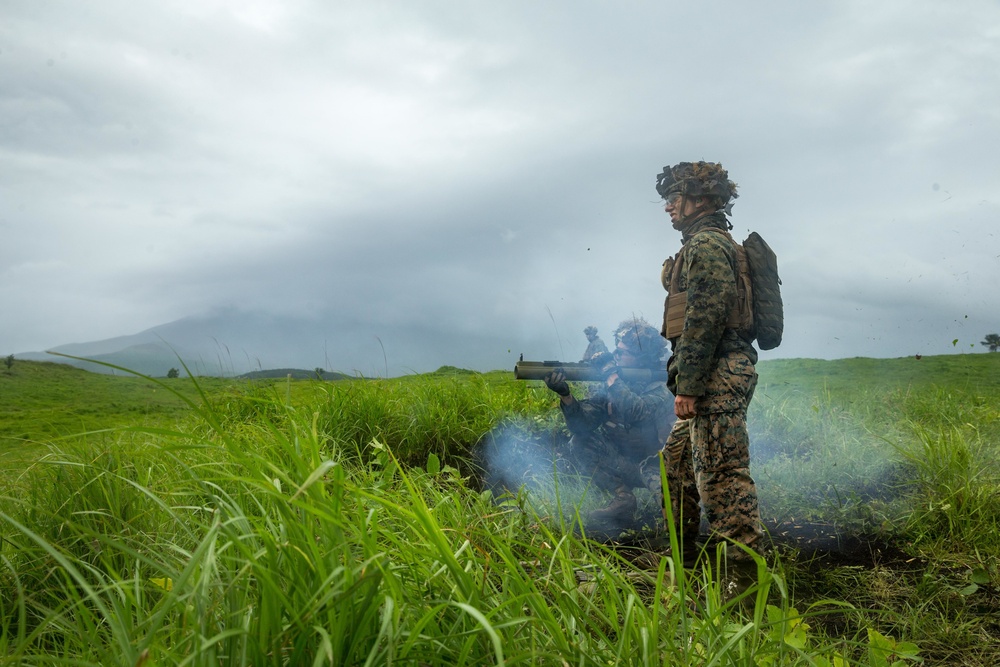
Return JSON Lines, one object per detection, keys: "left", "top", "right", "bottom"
{"left": 667, "top": 211, "right": 757, "bottom": 396}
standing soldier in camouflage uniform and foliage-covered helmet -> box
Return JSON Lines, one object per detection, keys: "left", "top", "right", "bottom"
{"left": 656, "top": 162, "right": 761, "bottom": 560}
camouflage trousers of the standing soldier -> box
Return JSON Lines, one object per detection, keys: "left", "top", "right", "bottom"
{"left": 662, "top": 356, "right": 761, "bottom": 559}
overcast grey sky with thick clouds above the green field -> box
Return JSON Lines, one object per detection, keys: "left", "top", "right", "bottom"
{"left": 0, "top": 0, "right": 1000, "bottom": 370}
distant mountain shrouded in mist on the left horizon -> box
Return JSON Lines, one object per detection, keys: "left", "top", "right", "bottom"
{"left": 15, "top": 308, "right": 541, "bottom": 377}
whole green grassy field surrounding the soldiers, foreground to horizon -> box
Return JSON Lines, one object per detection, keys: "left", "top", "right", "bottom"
{"left": 0, "top": 354, "right": 1000, "bottom": 666}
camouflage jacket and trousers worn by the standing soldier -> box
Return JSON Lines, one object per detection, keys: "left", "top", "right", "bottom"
{"left": 663, "top": 211, "right": 760, "bottom": 558}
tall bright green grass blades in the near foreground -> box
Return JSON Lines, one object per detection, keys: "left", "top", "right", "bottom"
{"left": 0, "top": 368, "right": 924, "bottom": 665}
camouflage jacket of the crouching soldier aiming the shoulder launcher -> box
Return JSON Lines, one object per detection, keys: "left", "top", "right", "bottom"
{"left": 560, "top": 379, "right": 675, "bottom": 458}
